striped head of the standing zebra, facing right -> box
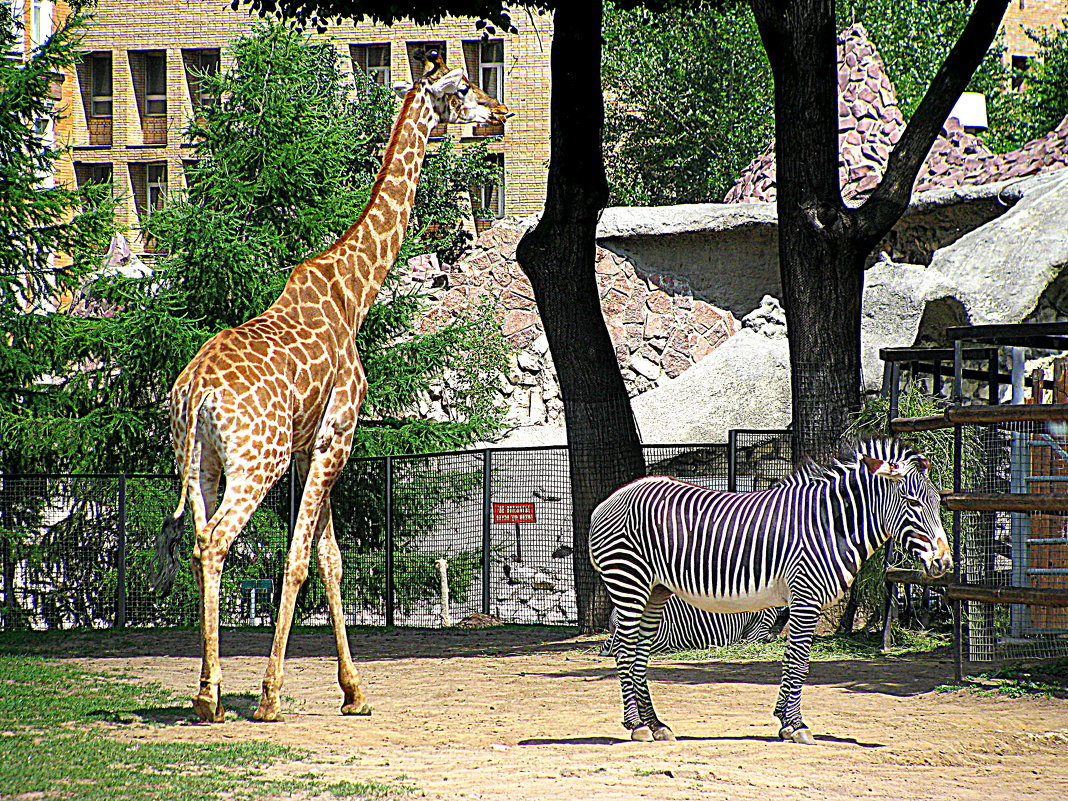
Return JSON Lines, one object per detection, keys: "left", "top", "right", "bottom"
{"left": 857, "top": 440, "right": 953, "bottom": 576}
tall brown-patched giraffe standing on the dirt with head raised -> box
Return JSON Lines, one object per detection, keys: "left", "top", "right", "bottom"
{"left": 154, "top": 50, "right": 511, "bottom": 722}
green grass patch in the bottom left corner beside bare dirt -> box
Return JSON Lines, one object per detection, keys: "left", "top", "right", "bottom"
{"left": 0, "top": 656, "right": 410, "bottom": 801}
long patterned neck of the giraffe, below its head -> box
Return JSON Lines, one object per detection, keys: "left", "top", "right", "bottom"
{"left": 283, "top": 87, "right": 436, "bottom": 333}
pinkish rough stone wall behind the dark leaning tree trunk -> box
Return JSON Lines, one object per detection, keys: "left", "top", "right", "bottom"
{"left": 408, "top": 220, "right": 740, "bottom": 426}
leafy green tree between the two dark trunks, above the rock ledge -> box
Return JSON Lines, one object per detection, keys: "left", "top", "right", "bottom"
{"left": 601, "top": 5, "right": 772, "bottom": 206}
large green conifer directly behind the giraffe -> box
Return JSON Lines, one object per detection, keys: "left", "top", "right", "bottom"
{"left": 5, "top": 18, "right": 504, "bottom": 472}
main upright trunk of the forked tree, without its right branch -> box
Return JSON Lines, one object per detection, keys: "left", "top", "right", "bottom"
{"left": 752, "top": 0, "right": 864, "bottom": 460}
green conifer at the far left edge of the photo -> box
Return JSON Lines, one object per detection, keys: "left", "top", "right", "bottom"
{"left": 0, "top": 3, "right": 114, "bottom": 473}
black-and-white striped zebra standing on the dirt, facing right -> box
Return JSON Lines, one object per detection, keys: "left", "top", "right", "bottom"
{"left": 590, "top": 439, "right": 953, "bottom": 744}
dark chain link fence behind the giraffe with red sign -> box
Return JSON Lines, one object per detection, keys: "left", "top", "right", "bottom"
{"left": 0, "top": 430, "right": 792, "bottom": 629}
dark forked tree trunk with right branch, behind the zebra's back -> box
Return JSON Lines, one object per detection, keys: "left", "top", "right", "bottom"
{"left": 751, "top": 0, "right": 1007, "bottom": 460}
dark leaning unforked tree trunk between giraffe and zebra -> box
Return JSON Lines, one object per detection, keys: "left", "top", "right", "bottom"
{"left": 517, "top": 2, "right": 645, "bottom": 633}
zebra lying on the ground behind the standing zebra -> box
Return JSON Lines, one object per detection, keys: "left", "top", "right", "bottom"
{"left": 598, "top": 595, "right": 789, "bottom": 657}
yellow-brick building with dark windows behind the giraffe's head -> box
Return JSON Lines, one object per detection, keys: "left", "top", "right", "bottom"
{"left": 41, "top": 0, "right": 552, "bottom": 251}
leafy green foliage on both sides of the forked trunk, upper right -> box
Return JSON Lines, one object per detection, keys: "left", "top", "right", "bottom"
{"left": 601, "top": 0, "right": 1068, "bottom": 205}
